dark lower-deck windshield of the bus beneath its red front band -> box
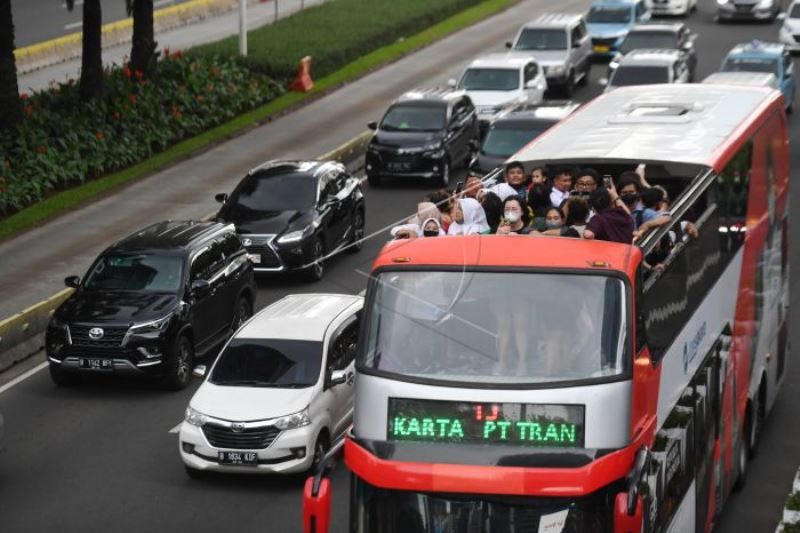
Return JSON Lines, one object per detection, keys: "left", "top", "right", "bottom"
{"left": 351, "top": 478, "right": 614, "bottom": 533}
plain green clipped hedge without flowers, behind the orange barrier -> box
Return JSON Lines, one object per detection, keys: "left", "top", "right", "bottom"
{"left": 189, "top": 0, "right": 480, "bottom": 81}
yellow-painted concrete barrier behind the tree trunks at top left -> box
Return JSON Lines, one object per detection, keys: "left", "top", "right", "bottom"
{"left": 14, "top": 0, "right": 238, "bottom": 74}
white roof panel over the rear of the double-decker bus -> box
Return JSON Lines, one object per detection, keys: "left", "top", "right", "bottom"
{"left": 511, "top": 84, "right": 780, "bottom": 168}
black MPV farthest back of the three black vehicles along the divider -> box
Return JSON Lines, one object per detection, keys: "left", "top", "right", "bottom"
{"left": 365, "top": 89, "right": 479, "bottom": 186}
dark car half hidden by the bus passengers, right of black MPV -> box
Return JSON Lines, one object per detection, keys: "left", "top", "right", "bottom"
{"left": 470, "top": 102, "right": 579, "bottom": 174}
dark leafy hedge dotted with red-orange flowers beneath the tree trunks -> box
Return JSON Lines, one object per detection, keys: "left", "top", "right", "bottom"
{"left": 0, "top": 51, "right": 282, "bottom": 217}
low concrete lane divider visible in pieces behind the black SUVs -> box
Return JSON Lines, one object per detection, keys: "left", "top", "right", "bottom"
{"left": 0, "top": 130, "right": 372, "bottom": 373}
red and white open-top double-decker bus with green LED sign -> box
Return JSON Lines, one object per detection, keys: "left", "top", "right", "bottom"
{"left": 304, "top": 85, "right": 789, "bottom": 533}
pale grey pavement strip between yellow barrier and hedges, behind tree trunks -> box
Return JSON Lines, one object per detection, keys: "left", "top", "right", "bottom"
{"left": 18, "top": 0, "right": 325, "bottom": 93}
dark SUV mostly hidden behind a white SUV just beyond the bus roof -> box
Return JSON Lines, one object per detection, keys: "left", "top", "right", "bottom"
{"left": 608, "top": 22, "right": 697, "bottom": 82}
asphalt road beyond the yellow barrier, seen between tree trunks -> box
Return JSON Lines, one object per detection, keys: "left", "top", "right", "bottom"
{"left": 11, "top": 0, "right": 188, "bottom": 48}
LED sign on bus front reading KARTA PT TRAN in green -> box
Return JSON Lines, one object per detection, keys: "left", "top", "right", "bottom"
{"left": 388, "top": 398, "right": 584, "bottom": 448}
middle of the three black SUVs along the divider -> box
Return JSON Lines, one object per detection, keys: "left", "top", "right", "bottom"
{"left": 216, "top": 160, "right": 365, "bottom": 281}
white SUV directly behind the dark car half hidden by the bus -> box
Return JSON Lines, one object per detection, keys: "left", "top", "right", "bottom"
{"left": 449, "top": 54, "right": 547, "bottom": 134}
